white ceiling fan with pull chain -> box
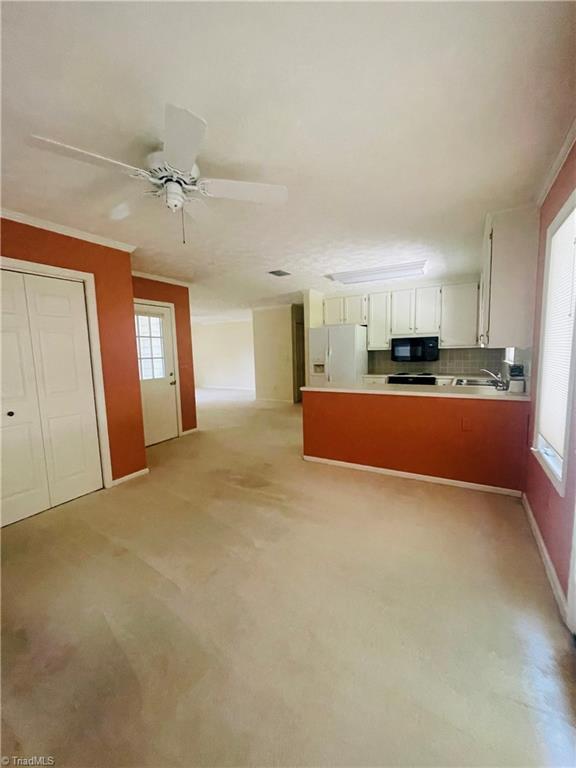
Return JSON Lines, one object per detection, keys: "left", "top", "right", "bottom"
{"left": 31, "top": 104, "right": 288, "bottom": 224}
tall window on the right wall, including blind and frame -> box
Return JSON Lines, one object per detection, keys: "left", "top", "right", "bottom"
{"left": 533, "top": 193, "right": 576, "bottom": 495}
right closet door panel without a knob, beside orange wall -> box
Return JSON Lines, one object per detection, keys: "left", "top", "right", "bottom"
{"left": 24, "top": 275, "right": 102, "bottom": 506}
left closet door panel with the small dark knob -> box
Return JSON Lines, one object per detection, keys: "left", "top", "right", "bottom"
{"left": 2, "top": 270, "right": 50, "bottom": 525}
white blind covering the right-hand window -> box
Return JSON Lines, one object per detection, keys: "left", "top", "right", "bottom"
{"left": 537, "top": 210, "right": 576, "bottom": 468}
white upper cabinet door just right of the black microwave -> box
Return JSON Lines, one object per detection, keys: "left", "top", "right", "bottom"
{"left": 440, "top": 283, "right": 478, "bottom": 347}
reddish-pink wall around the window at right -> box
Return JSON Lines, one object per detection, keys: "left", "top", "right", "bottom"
{"left": 526, "top": 144, "right": 576, "bottom": 595}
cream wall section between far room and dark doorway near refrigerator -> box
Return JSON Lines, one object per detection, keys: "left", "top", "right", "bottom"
{"left": 252, "top": 306, "right": 294, "bottom": 402}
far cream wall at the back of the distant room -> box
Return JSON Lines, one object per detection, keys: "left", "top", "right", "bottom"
{"left": 192, "top": 320, "right": 255, "bottom": 390}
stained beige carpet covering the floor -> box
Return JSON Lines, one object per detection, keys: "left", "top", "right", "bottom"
{"left": 3, "top": 393, "right": 576, "bottom": 768}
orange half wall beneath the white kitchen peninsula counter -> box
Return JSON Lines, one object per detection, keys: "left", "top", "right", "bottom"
{"left": 302, "top": 392, "right": 530, "bottom": 490}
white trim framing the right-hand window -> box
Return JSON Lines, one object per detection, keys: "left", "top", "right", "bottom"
{"left": 531, "top": 189, "right": 576, "bottom": 497}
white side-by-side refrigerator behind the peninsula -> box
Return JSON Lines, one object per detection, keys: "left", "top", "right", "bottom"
{"left": 308, "top": 325, "right": 368, "bottom": 387}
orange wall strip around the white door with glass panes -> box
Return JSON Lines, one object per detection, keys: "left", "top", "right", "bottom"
{"left": 132, "top": 277, "right": 196, "bottom": 431}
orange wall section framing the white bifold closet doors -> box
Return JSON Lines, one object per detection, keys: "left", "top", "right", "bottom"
{"left": 2, "top": 219, "right": 146, "bottom": 479}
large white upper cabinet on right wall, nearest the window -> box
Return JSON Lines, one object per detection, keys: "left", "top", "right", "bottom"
{"left": 479, "top": 206, "right": 538, "bottom": 349}
